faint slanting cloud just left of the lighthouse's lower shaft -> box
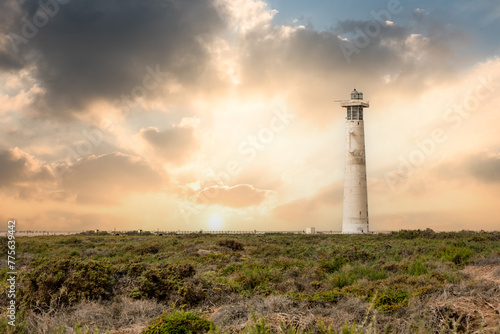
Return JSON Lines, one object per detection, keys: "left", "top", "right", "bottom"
{"left": 273, "top": 183, "right": 344, "bottom": 222}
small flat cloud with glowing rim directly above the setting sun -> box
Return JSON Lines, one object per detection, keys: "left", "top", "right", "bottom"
{"left": 196, "top": 184, "right": 271, "bottom": 208}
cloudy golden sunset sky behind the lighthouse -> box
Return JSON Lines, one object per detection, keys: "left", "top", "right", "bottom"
{"left": 0, "top": 0, "right": 500, "bottom": 231}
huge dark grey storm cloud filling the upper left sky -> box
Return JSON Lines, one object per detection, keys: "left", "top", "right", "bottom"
{"left": 0, "top": 0, "right": 223, "bottom": 117}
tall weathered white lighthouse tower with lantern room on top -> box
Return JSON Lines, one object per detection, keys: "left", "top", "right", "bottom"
{"left": 340, "top": 89, "right": 370, "bottom": 234}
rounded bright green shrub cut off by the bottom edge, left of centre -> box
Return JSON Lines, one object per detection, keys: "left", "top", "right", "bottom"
{"left": 144, "top": 310, "right": 214, "bottom": 334}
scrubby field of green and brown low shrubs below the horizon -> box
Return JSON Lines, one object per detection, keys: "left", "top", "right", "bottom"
{"left": 0, "top": 230, "right": 500, "bottom": 334}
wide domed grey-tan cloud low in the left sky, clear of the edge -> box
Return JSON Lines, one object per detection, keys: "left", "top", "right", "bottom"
{"left": 62, "top": 153, "right": 164, "bottom": 205}
